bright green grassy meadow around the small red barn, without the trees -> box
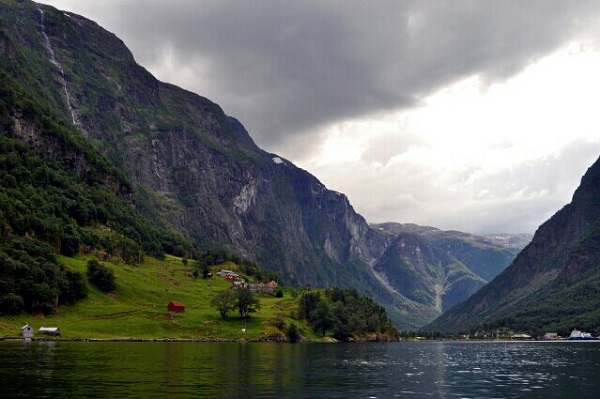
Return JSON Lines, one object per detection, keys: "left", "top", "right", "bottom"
{"left": 0, "top": 257, "right": 314, "bottom": 340}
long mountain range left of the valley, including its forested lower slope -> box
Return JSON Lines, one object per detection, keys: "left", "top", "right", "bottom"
{"left": 0, "top": 0, "right": 524, "bottom": 328}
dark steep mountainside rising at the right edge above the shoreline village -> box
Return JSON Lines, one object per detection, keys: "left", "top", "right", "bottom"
{"left": 426, "top": 156, "right": 600, "bottom": 334}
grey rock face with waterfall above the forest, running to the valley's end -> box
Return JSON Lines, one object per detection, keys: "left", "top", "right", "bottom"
{"left": 0, "top": 1, "right": 514, "bottom": 327}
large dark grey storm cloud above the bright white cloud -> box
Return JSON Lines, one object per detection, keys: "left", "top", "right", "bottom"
{"left": 76, "top": 0, "right": 598, "bottom": 155}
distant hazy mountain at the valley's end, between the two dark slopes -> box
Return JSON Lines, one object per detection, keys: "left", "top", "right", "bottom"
{"left": 372, "top": 223, "right": 527, "bottom": 326}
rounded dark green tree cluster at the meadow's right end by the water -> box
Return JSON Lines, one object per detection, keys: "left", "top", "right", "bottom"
{"left": 298, "top": 288, "right": 398, "bottom": 341}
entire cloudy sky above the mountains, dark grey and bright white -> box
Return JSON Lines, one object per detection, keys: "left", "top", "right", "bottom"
{"left": 36, "top": 0, "right": 600, "bottom": 234}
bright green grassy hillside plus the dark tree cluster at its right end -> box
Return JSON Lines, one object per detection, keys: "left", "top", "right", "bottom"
{"left": 0, "top": 256, "right": 397, "bottom": 341}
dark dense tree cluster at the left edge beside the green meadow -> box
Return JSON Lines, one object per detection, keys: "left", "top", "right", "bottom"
{"left": 0, "top": 237, "right": 88, "bottom": 314}
